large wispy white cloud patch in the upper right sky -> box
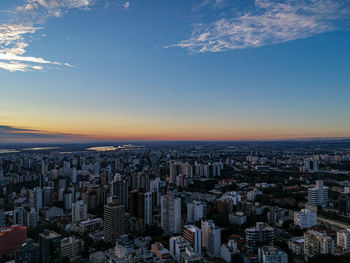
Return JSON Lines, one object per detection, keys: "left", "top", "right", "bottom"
{"left": 171, "top": 0, "right": 350, "bottom": 53}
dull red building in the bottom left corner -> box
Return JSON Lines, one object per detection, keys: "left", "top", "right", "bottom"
{"left": 0, "top": 225, "right": 27, "bottom": 257}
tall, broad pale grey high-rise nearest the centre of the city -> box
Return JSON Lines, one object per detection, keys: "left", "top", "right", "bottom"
{"left": 160, "top": 191, "right": 181, "bottom": 234}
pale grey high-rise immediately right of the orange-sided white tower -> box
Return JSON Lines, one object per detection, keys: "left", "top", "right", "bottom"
{"left": 201, "top": 220, "right": 221, "bottom": 256}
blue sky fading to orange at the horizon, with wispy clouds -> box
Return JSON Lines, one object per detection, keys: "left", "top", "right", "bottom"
{"left": 0, "top": 0, "right": 350, "bottom": 142}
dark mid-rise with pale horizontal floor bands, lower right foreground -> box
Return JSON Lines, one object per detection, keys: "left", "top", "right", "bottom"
{"left": 245, "top": 222, "right": 275, "bottom": 254}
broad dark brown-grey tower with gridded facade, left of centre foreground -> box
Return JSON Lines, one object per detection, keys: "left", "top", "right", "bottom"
{"left": 104, "top": 203, "right": 125, "bottom": 243}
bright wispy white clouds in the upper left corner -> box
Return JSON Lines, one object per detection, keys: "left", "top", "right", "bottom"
{"left": 0, "top": 0, "right": 94, "bottom": 72}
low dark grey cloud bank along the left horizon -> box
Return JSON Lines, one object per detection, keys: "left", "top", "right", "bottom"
{"left": 0, "top": 125, "right": 89, "bottom": 143}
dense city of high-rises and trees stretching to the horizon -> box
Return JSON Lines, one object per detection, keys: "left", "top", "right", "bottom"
{"left": 0, "top": 140, "right": 350, "bottom": 263}
